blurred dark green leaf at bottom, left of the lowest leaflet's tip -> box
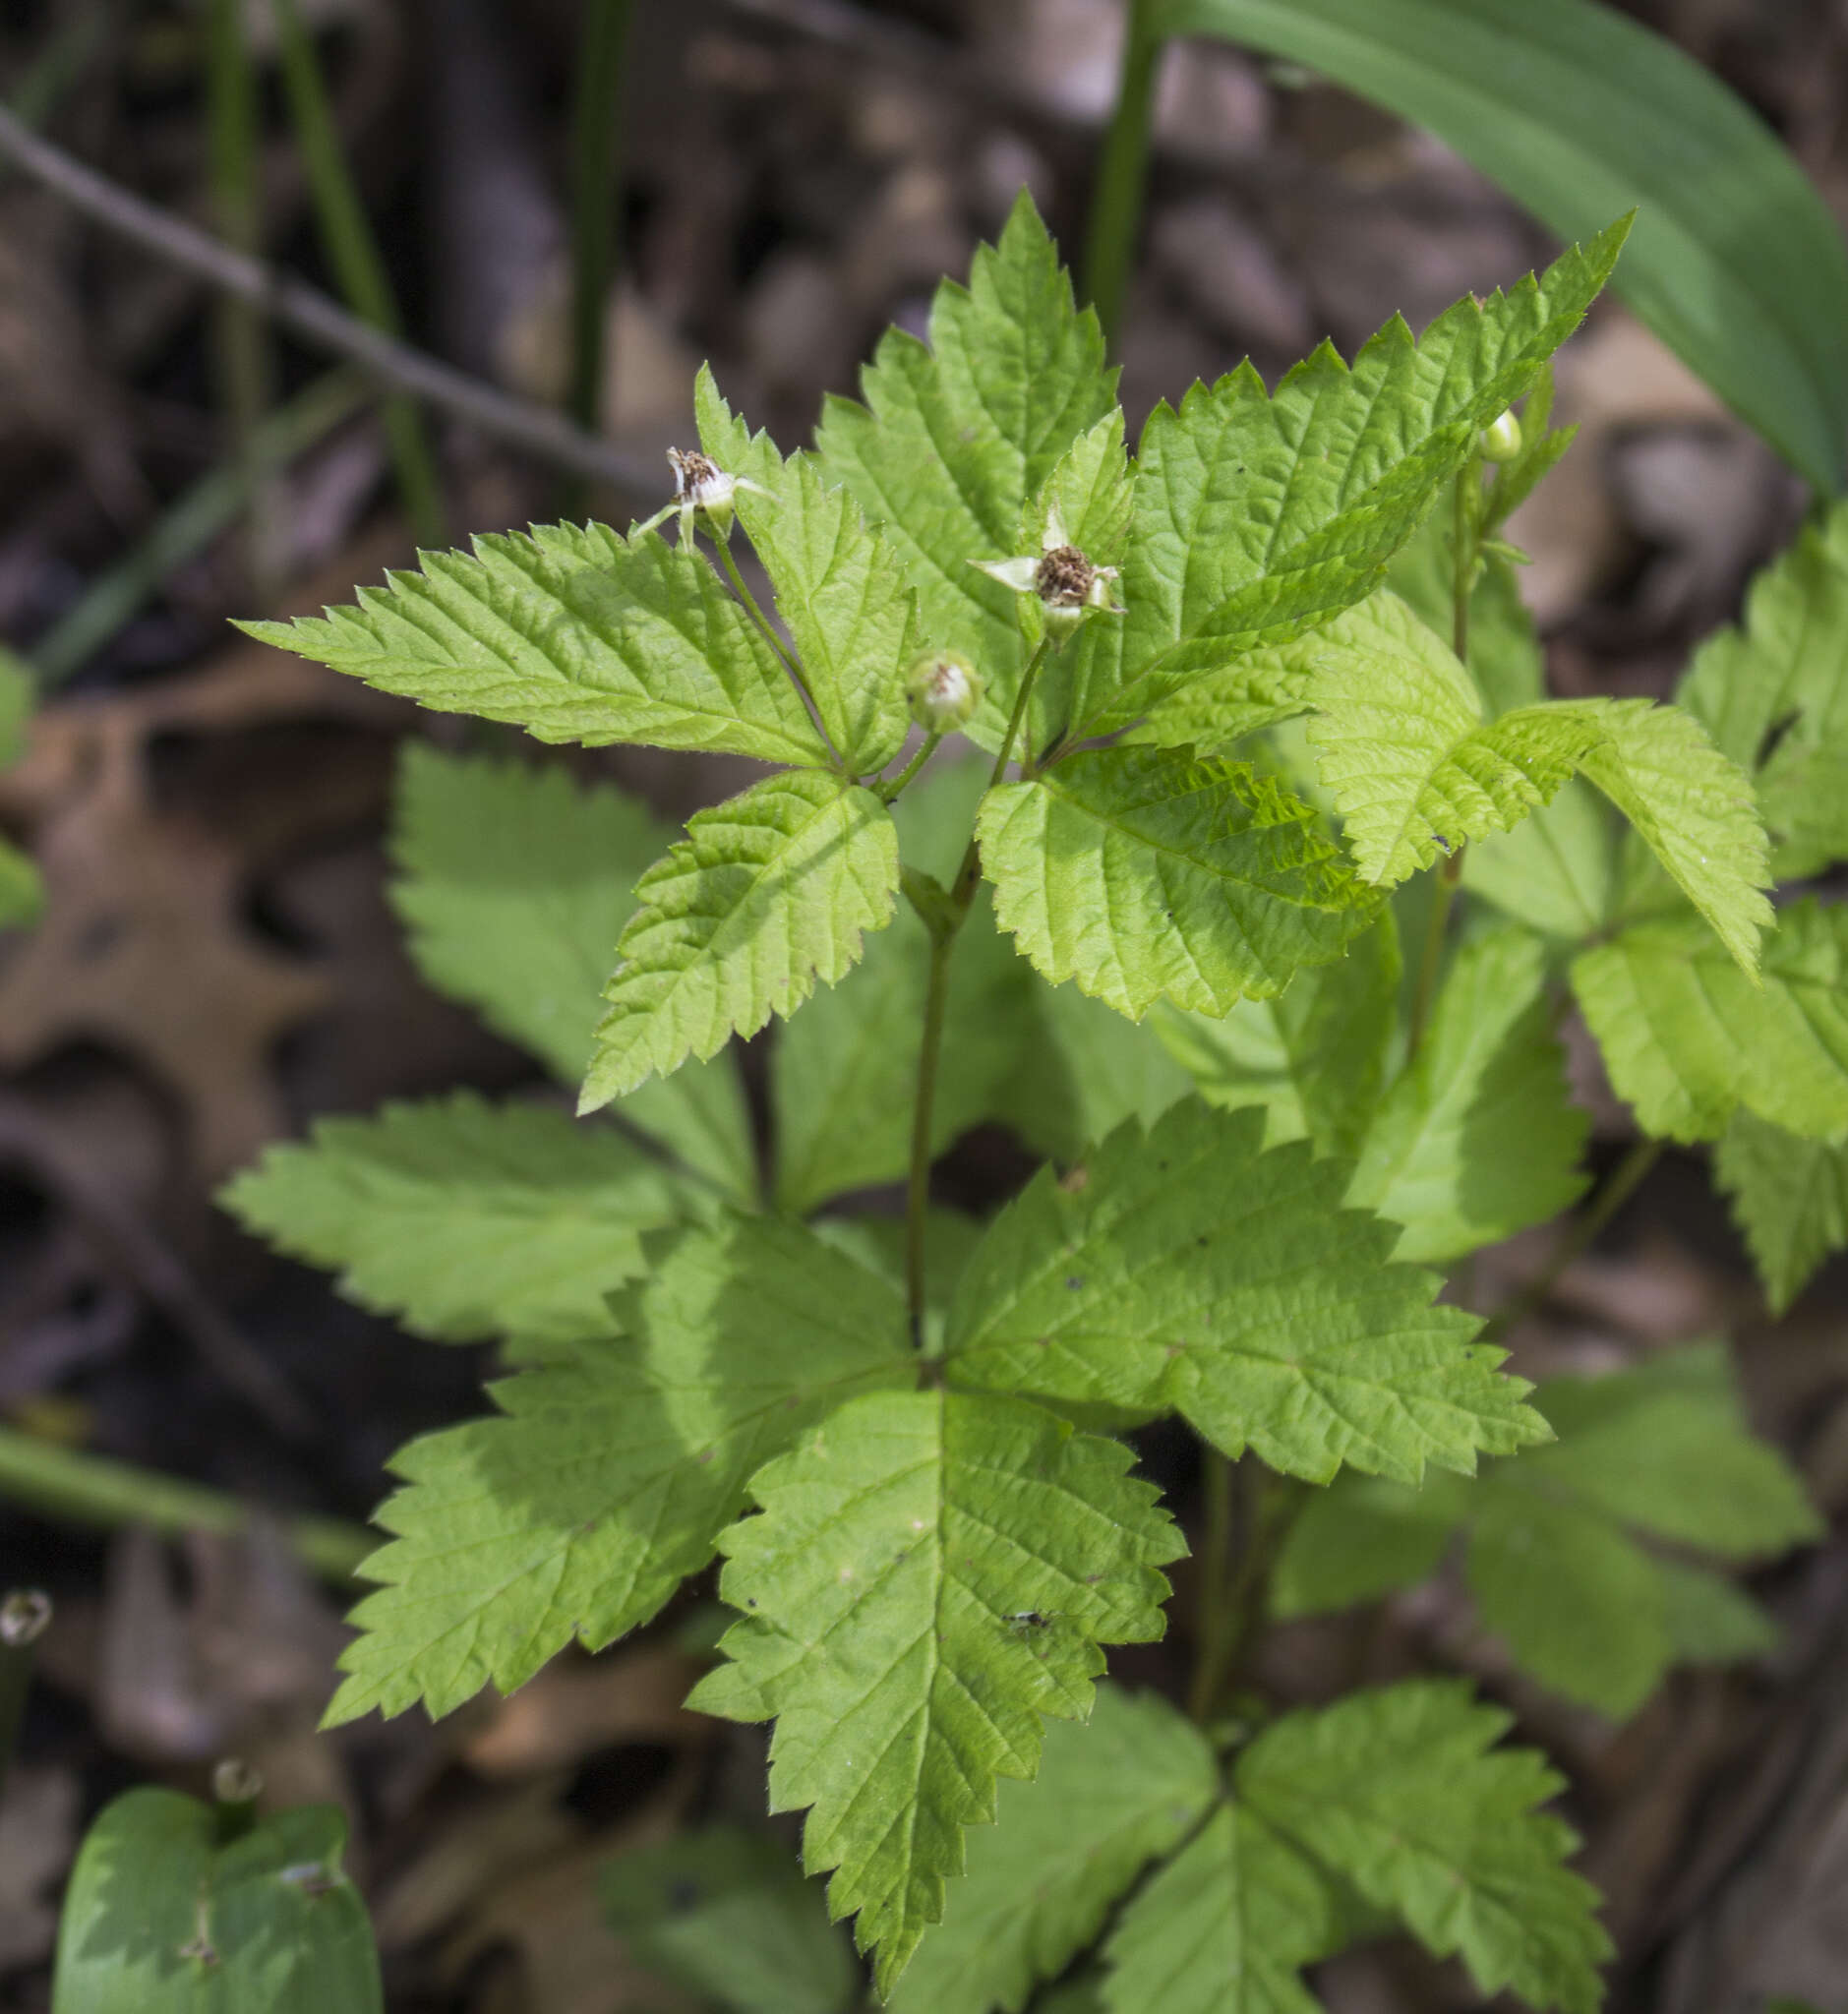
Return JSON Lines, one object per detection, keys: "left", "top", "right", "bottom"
{"left": 599, "top": 1824, "right": 861, "bottom": 2014}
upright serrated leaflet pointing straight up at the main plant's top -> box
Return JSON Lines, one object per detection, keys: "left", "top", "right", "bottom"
{"left": 816, "top": 194, "right": 1116, "bottom": 749}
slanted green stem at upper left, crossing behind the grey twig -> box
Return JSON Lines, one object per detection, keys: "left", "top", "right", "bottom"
{"left": 270, "top": 0, "right": 447, "bottom": 546}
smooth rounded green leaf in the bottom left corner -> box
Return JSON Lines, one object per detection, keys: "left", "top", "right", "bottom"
{"left": 52, "top": 1789, "right": 385, "bottom": 2014}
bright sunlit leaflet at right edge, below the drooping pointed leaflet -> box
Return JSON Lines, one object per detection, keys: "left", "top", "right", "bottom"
{"left": 1572, "top": 900, "right": 1848, "bottom": 1142}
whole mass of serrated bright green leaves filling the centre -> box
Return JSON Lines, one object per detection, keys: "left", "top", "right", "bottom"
{"left": 225, "top": 200, "right": 1848, "bottom": 2014}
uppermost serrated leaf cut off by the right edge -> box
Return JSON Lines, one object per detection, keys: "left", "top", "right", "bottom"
{"left": 1677, "top": 504, "right": 1848, "bottom": 880}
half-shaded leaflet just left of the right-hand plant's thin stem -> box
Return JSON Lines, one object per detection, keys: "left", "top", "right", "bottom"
{"left": 1153, "top": 911, "right": 1399, "bottom": 1159}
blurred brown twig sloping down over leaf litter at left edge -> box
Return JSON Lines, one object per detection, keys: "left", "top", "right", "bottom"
{"left": 0, "top": 1105, "right": 315, "bottom": 1442}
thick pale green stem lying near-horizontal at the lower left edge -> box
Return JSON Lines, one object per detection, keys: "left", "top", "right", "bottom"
{"left": 0, "top": 1426, "right": 377, "bottom": 1581}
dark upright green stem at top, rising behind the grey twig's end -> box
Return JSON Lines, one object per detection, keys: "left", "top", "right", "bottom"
{"left": 565, "top": 0, "right": 632, "bottom": 517}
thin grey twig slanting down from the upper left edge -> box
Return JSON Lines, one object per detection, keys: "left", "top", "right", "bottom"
{"left": 0, "top": 107, "right": 665, "bottom": 498}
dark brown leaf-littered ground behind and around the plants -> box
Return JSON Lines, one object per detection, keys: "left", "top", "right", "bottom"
{"left": 0, "top": 0, "right": 1848, "bottom": 2014}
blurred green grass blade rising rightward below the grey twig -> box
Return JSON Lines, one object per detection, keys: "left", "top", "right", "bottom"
{"left": 27, "top": 369, "right": 371, "bottom": 684}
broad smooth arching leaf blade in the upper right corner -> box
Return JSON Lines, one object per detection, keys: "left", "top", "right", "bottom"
{"left": 1159, "top": 0, "right": 1848, "bottom": 490}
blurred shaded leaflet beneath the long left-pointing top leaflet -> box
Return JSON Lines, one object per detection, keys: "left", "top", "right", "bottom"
{"left": 391, "top": 741, "right": 755, "bottom": 1203}
